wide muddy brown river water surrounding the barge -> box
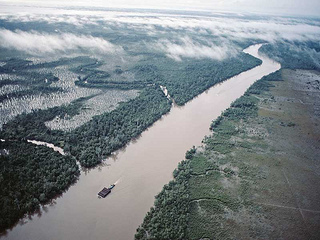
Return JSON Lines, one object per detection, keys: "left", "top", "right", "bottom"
{"left": 5, "top": 45, "right": 280, "bottom": 240}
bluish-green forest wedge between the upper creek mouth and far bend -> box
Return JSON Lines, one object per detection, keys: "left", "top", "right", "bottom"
{"left": 134, "top": 53, "right": 261, "bottom": 105}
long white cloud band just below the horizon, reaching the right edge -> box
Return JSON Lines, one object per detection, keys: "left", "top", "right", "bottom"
{"left": 80, "top": 12, "right": 320, "bottom": 42}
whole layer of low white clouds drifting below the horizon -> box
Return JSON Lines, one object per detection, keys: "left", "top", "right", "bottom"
{"left": 0, "top": 9, "right": 320, "bottom": 60}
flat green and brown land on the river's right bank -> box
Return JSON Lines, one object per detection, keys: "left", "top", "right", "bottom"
{"left": 136, "top": 70, "right": 320, "bottom": 239}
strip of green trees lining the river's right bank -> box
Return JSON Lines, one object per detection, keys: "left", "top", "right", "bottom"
{"left": 135, "top": 70, "right": 281, "bottom": 240}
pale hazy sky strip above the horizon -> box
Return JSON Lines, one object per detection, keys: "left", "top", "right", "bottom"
{"left": 0, "top": 0, "right": 320, "bottom": 16}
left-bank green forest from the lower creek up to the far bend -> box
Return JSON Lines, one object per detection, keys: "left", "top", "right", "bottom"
{"left": 1, "top": 48, "right": 261, "bottom": 167}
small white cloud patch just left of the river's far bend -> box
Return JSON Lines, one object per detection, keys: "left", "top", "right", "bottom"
{"left": 154, "top": 37, "right": 239, "bottom": 61}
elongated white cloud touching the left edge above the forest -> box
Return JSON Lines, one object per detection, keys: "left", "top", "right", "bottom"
{"left": 0, "top": 29, "right": 123, "bottom": 55}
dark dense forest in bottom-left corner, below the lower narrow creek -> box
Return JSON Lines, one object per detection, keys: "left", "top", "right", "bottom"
{"left": 0, "top": 141, "right": 80, "bottom": 232}
